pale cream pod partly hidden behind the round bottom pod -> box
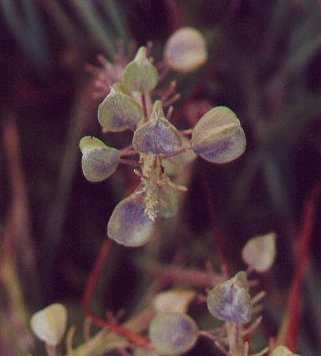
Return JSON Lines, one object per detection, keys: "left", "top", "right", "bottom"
{"left": 153, "top": 289, "right": 196, "bottom": 313}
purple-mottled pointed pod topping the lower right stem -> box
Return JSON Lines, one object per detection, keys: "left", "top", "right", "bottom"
{"left": 207, "top": 272, "right": 252, "bottom": 323}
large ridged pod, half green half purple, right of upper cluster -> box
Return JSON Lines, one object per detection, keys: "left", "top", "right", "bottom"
{"left": 192, "top": 106, "right": 246, "bottom": 163}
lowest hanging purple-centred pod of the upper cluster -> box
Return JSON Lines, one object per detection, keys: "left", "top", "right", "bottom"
{"left": 107, "top": 192, "right": 154, "bottom": 247}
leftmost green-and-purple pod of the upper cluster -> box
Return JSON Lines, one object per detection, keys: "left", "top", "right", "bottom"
{"left": 79, "top": 136, "right": 120, "bottom": 182}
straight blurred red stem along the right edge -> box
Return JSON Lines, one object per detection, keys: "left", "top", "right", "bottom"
{"left": 286, "top": 182, "right": 321, "bottom": 352}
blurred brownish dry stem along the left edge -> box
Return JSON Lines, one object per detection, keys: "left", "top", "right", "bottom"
{"left": 0, "top": 115, "right": 36, "bottom": 355}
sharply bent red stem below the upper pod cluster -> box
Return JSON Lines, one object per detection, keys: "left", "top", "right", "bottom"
{"left": 82, "top": 239, "right": 150, "bottom": 348}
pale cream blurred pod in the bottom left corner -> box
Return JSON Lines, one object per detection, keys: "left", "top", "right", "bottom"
{"left": 30, "top": 303, "right": 67, "bottom": 346}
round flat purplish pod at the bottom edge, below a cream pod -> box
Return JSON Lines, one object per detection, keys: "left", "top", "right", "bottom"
{"left": 148, "top": 313, "right": 199, "bottom": 355}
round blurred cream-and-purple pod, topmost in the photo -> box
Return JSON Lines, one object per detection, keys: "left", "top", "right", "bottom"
{"left": 164, "top": 27, "right": 207, "bottom": 73}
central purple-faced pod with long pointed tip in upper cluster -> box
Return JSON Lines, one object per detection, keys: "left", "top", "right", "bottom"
{"left": 133, "top": 100, "right": 182, "bottom": 155}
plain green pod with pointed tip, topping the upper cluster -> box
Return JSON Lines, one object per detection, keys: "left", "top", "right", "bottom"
{"left": 123, "top": 47, "right": 158, "bottom": 93}
